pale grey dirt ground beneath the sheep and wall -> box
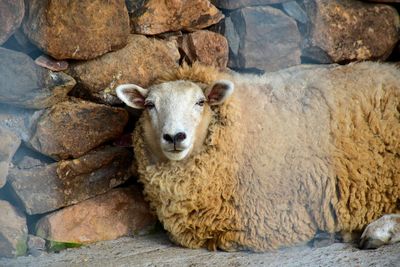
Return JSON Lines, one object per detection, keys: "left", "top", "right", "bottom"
{"left": 0, "top": 234, "right": 400, "bottom": 267}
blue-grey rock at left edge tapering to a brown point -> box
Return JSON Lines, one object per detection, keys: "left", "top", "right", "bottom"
{"left": 0, "top": 47, "right": 75, "bottom": 109}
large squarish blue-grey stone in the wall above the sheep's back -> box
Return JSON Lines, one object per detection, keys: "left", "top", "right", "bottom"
{"left": 222, "top": 7, "right": 301, "bottom": 71}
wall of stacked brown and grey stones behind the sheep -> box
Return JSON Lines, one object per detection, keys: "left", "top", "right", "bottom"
{"left": 0, "top": 0, "right": 400, "bottom": 257}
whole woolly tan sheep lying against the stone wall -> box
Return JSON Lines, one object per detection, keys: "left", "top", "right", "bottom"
{"left": 116, "top": 62, "right": 400, "bottom": 252}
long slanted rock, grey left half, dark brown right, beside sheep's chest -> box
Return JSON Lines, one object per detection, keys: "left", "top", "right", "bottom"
{"left": 8, "top": 147, "right": 132, "bottom": 215}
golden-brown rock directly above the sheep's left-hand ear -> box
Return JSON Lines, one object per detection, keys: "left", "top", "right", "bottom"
{"left": 68, "top": 35, "right": 180, "bottom": 104}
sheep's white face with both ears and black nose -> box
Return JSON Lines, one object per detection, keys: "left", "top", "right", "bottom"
{"left": 116, "top": 80, "right": 234, "bottom": 160}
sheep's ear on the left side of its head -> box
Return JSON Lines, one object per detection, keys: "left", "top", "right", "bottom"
{"left": 115, "top": 84, "right": 148, "bottom": 109}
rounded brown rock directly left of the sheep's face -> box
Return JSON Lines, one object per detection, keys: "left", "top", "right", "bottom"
{"left": 29, "top": 99, "right": 128, "bottom": 160}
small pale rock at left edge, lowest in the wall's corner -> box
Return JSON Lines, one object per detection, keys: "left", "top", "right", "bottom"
{"left": 0, "top": 200, "right": 28, "bottom": 258}
